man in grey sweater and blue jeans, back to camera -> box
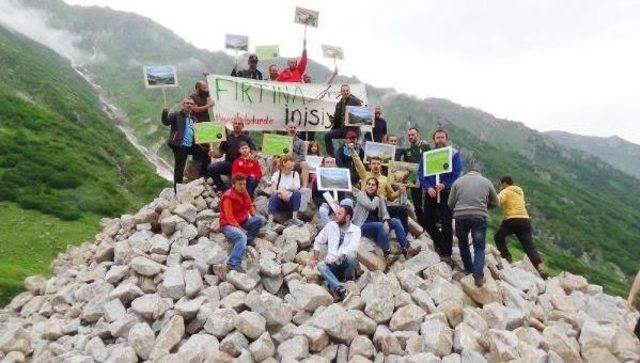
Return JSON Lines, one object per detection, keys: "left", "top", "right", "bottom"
{"left": 448, "top": 170, "right": 498, "bottom": 287}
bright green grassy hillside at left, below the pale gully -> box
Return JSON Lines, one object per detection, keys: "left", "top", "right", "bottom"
{"left": 0, "top": 27, "right": 166, "bottom": 303}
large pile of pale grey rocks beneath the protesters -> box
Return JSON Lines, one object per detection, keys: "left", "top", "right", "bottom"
{"left": 0, "top": 179, "right": 640, "bottom": 363}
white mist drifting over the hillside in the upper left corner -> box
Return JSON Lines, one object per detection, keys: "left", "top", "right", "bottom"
{"left": 0, "top": 0, "right": 89, "bottom": 64}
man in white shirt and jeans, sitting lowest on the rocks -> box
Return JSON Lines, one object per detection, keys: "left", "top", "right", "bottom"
{"left": 310, "top": 205, "right": 361, "bottom": 300}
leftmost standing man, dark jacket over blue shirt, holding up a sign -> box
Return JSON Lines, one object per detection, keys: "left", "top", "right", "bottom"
{"left": 161, "top": 98, "right": 205, "bottom": 191}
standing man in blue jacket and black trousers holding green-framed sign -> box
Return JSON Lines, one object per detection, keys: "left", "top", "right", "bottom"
{"left": 418, "top": 129, "right": 462, "bottom": 260}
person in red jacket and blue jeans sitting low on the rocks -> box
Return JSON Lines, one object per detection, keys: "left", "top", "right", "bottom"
{"left": 220, "top": 174, "right": 266, "bottom": 272}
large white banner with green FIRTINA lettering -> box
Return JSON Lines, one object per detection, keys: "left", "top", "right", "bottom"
{"left": 202, "top": 75, "right": 368, "bottom": 131}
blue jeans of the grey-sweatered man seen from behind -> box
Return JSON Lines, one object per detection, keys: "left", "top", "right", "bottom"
{"left": 456, "top": 217, "right": 487, "bottom": 278}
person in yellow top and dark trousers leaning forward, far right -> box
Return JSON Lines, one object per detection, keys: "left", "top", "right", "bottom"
{"left": 493, "top": 176, "right": 549, "bottom": 279}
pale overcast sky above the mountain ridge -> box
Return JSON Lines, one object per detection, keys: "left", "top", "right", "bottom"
{"left": 66, "top": 0, "right": 640, "bottom": 143}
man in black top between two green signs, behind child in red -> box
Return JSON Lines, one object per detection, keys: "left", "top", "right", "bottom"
{"left": 207, "top": 119, "right": 256, "bottom": 192}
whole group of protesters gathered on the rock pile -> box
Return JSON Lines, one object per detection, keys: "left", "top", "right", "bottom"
{"left": 162, "top": 59, "right": 547, "bottom": 298}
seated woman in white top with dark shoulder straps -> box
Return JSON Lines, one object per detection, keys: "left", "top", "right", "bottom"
{"left": 267, "top": 155, "right": 303, "bottom": 225}
